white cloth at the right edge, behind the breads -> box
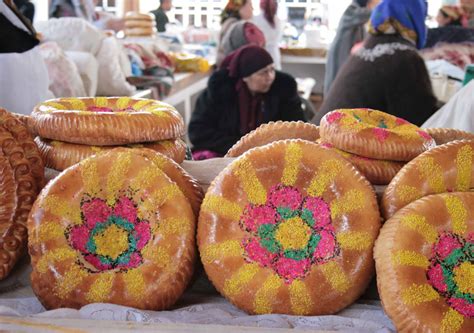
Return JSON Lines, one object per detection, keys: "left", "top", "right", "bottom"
{"left": 422, "top": 80, "right": 474, "bottom": 133}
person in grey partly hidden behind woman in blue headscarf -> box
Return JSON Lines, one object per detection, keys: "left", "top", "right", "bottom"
{"left": 324, "top": 0, "right": 379, "bottom": 95}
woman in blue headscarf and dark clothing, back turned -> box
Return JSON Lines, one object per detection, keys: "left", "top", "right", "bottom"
{"left": 313, "top": 0, "right": 437, "bottom": 125}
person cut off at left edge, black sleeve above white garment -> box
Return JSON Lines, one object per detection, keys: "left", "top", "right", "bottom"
{"left": 0, "top": 0, "right": 54, "bottom": 115}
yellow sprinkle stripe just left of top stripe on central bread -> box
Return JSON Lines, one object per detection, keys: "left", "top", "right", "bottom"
{"left": 234, "top": 157, "right": 267, "bottom": 205}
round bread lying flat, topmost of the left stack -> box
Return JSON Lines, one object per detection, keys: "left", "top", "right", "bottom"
{"left": 31, "top": 97, "right": 184, "bottom": 146}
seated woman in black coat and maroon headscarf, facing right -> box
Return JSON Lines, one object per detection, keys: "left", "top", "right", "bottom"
{"left": 188, "top": 45, "right": 305, "bottom": 159}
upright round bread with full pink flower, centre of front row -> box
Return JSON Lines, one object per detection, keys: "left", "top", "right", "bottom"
{"left": 197, "top": 140, "right": 380, "bottom": 315}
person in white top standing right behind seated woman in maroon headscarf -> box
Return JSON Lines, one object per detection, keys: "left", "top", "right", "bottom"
{"left": 252, "top": 0, "right": 283, "bottom": 70}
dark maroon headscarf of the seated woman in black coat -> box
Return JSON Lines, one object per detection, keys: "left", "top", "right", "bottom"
{"left": 221, "top": 45, "right": 273, "bottom": 135}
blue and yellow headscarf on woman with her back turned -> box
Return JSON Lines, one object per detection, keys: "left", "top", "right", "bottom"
{"left": 369, "top": 0, "right": 428, "bottom": 49}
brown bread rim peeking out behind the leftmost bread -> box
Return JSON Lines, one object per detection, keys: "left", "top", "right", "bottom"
{"left": 0, "top": 108, "right": 44, "bottom": 189}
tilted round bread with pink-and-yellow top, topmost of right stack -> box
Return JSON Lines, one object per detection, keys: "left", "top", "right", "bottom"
{"left": 320, "top": 109, "right": 436, "bottom": 161}
